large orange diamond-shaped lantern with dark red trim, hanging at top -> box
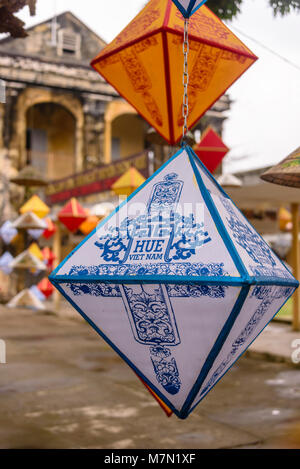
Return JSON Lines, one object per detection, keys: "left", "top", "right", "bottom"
{"left": 92, "top": 0, "right": 257, "bottom": 144}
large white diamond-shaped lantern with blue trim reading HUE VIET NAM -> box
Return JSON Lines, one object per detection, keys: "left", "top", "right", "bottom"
{"left": 50, "top": 147, "right": 298, "bottom": 418}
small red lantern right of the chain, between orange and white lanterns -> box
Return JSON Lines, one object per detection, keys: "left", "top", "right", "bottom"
{"left": 194, "top": 127, "right": 229, "bottom": 173}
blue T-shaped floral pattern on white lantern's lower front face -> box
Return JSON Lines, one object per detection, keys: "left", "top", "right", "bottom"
{"left": 66, "top": 282, "right": 228, "bottom": 394}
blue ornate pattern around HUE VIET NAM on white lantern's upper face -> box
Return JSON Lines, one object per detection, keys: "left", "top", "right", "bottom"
{"left": 95, "top": 173, "right": 211, "bottom": 264}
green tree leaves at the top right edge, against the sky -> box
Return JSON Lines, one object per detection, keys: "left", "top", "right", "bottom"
{"left": 206, "top": 0, "right": 300, "bottom": 20}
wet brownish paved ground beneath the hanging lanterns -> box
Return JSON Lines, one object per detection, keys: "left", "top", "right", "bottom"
{"left": 0, "top": 307, "right": 300, "bottom": 449}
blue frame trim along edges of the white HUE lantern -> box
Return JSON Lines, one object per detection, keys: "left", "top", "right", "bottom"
{"left": 49, "top": 145, "right": 299, "bottom": 419}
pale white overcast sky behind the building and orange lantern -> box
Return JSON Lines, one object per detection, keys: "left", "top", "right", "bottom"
{"left": 18, "top": 0, "right": 300, "bottom": 172}
